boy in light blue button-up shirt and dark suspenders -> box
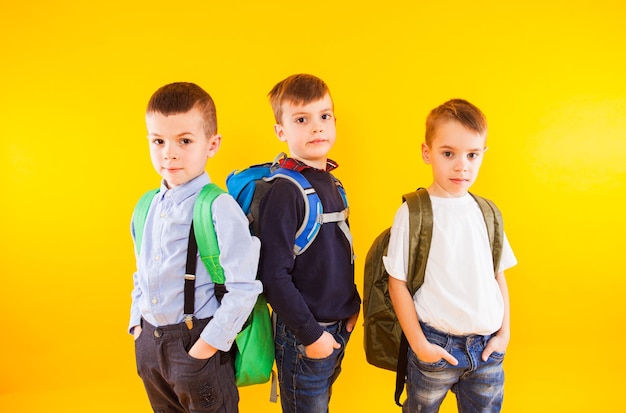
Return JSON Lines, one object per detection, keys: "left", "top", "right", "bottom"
{"left": 129, "top": 82, "right": 262, "bottom": 413}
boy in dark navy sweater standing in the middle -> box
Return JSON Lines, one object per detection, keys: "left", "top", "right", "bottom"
{"left": 259, "top": 74, "right": 361, "bottom": 413}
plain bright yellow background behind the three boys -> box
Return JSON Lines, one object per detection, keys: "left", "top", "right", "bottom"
{"left": 0, "top": 0, "right": 626, "bottom": 413}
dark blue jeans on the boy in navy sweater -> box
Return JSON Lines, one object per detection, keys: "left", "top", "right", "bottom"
{"left": 274, "top": 319, "right": 350, "bottom": 413}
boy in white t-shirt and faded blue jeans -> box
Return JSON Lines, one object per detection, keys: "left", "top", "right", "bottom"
{"left": 383, "top": 99, "right": 517, "bottom": 413}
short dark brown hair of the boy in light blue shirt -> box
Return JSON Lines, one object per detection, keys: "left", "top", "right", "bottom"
{"left": 146, "top": 82, "right": 217, "bottom": 137}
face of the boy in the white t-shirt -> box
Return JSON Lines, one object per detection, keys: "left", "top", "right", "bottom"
{"left": 422, "top": 121, "right": 487, "bottom": 198}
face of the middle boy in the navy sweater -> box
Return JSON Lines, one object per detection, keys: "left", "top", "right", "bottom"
{"left": 274, "top": 94, "right": 336, "bottom": 170}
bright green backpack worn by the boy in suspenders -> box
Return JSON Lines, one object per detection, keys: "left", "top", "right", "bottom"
{"left": 133, "top": 184, "right": 274, "bottom": 387}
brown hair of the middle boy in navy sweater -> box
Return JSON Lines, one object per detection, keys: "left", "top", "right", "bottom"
{"left": 267, "top": 74, "right": 332, "bottom": 123}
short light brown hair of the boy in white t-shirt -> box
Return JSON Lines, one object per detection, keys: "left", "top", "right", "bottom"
{"left": 425, "top": 99, "right": 487, "bottom": 146}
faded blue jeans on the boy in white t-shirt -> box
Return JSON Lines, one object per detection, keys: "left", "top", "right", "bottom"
{"left": 402, "top": 323, "right": 504, "bottom": 413}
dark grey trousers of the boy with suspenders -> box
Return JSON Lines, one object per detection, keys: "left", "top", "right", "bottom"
{"left": 135, "top": 319, "right": 239, "bottom": 413}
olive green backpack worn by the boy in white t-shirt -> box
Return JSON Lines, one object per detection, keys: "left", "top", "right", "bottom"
{"left": 363, "top": 188, "right": 503, "bottom": 406}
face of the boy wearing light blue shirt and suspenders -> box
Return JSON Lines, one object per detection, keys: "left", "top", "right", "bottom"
{"left": 146, "top": 108, "right": 221, "bottom": 188}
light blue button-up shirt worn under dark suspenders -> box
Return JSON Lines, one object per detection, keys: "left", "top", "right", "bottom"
{"left": 129, "top": 172, "right": 262, "bottom": 351}
